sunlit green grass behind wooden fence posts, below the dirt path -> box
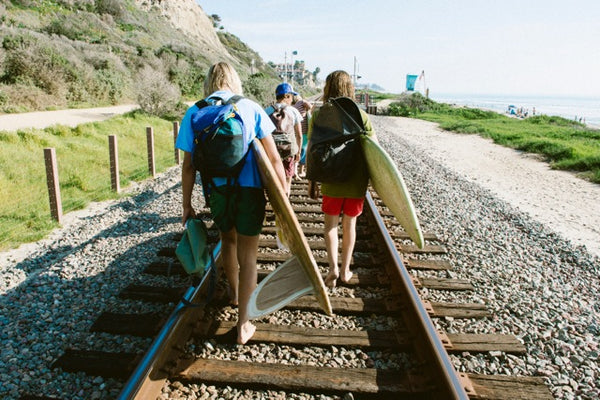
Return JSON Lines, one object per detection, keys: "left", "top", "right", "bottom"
{"left": 0, "top": 112, "right": 174, "bottom": 251}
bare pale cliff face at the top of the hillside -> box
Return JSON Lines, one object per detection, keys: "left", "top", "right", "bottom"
{"left": 135, "top": 0, "right": 233, "bottom": 62}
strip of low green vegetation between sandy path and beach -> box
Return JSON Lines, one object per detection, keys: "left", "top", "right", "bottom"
{"left": 388, "top": 93, "right": 600, "bottom": 183}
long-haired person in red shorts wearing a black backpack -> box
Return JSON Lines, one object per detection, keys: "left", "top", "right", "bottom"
{"left": 306, "top": 70, "right": 375, "bottom": 287}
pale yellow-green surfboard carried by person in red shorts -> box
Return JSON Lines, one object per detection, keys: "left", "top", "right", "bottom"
{"left": 361, "top": 135, "right": 425, "bottom": 249}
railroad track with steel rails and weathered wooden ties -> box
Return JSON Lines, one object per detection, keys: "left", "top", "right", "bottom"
{"left": 24, "top": 182, "right": 552, "bottom": 399}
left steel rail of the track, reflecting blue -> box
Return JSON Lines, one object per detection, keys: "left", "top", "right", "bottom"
{"left": 118, "top": 241, "right": 221, "bottom": 400}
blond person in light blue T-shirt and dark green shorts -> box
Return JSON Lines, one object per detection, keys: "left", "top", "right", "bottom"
{"left": 176, "top": 62, "right": 285, "bottom": 344}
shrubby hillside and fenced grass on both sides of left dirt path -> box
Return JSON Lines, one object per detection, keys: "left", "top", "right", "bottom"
{"left": 0, "top": 0, "right": 314, "bottom": 251}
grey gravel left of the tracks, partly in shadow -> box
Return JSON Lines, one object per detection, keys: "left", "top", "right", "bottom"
{"left": 0, "top": 180, "right": 199, "bottom": 398}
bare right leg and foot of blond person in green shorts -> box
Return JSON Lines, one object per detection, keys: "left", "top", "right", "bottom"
{"left": 237, "top": 234, "right": 258, "bottom": 344}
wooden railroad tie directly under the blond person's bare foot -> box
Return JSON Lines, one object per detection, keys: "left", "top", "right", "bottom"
{"left": 202, "top": 321, "right": 410, "bottom": 350}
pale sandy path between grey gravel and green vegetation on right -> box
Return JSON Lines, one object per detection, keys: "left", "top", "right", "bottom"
{"left": 373, "top": 117, "right": 600, "bottom": 257}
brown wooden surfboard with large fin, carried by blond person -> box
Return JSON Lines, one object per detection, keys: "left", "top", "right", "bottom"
{"left": 248, "top": 139, "right": 333, "bottom": 319}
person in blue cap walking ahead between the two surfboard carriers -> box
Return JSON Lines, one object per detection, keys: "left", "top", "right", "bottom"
{"left": 265, "top": 82, "right": 302, "bottom": 196}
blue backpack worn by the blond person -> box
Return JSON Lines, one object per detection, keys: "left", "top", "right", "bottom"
{"left": 192, "top": 96, "right": 248, "bottom": 193}
